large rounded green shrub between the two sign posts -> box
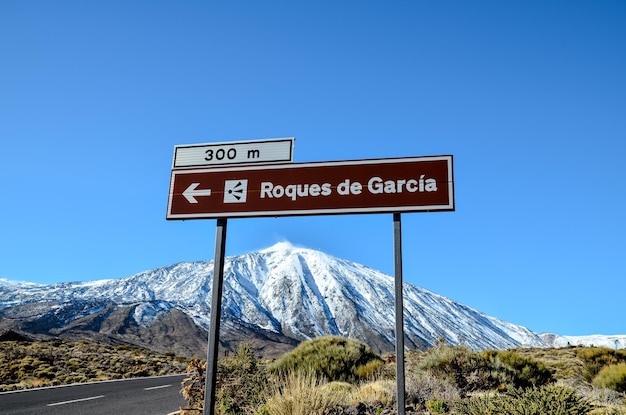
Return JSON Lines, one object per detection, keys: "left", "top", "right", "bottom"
{"left": 268, "top": 336, "right": 383, "bottom": 383}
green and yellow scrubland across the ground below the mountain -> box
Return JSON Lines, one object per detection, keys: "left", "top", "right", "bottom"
{"left": 0, "top": 336, "right": 626, "bottom": 415}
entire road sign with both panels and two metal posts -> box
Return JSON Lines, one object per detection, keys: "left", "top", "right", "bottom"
{"left": 166, "top": 138, "right": 454, "bottom": 415}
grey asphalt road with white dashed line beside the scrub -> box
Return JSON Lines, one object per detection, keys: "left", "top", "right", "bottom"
{"left": 0, "top": 375, "right": 187, "bottom": 415}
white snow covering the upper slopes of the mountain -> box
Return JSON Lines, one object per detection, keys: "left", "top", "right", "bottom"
{"left": 0, "top": 243, "right": 620, "bottom": 350}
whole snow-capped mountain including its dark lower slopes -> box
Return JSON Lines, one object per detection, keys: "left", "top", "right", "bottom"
{"left": 0, "top": 243, "right": 620, "bottom": 355}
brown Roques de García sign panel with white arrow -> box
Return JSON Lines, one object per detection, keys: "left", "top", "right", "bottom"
{"left": 167, "top": 156, "right": 454, "bottom": 219}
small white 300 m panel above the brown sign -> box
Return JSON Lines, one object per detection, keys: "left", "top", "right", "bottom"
{"left": 172, "top": 137, "right": 294, "bottom": 169}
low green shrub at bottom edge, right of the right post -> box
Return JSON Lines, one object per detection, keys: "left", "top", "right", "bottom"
{"left": 454, "top": 385, "right": 591, "bottom": 415}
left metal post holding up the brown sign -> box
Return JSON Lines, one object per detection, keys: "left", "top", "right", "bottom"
{"left": 204, "top": 218, "right": 227, "bottom": 415}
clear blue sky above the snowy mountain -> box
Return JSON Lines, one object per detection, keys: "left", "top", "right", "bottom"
{"left": 0, "top": 0, "right": 626, "bottom": 335}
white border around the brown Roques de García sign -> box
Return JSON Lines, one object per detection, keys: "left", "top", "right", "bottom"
{"left": 166, "top": 155, "right": 455, "bottom": 220}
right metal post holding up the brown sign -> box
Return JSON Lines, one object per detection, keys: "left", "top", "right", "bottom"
{"left": 393, "top": 213, "right": 406, "bottom": 415}
